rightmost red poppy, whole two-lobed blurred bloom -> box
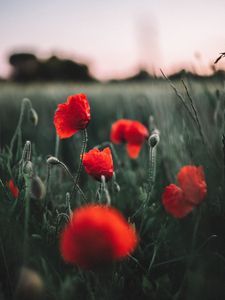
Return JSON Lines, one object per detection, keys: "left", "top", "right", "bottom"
{"left": 162, "top": 166, "right": 207, "bottom": 218}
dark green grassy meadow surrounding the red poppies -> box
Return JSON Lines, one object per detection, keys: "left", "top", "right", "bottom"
{"left": 0, "top": 79, "right": 225, "bottom": 300}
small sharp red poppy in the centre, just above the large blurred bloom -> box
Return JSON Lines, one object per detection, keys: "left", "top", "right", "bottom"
{"left": 82, "top": 147, "right": 114, "bottom": 181}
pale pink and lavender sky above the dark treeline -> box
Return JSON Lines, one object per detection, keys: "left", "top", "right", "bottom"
{"left": 0, "top": 0, "right": 225, "bottom": 80}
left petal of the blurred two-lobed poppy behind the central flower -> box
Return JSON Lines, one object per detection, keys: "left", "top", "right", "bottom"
{"left": 110, "top": 119, "right": 132, "bottom": 144}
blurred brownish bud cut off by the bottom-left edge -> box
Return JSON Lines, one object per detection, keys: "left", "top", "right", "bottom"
{"left": 14, "top": 267, "right": 45, "bottom": 300}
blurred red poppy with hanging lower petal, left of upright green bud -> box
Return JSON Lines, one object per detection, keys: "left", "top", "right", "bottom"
{"left": 110, "top": 119, "right": 149, "bottom": 159}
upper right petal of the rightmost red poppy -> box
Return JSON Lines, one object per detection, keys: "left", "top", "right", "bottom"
{"left": 177, "top": 166, "right": 207, "bottom": 205}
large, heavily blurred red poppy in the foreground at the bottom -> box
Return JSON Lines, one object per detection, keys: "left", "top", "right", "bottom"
{"left": 60, "top": 204, "right": 138, "bottom": 269}
